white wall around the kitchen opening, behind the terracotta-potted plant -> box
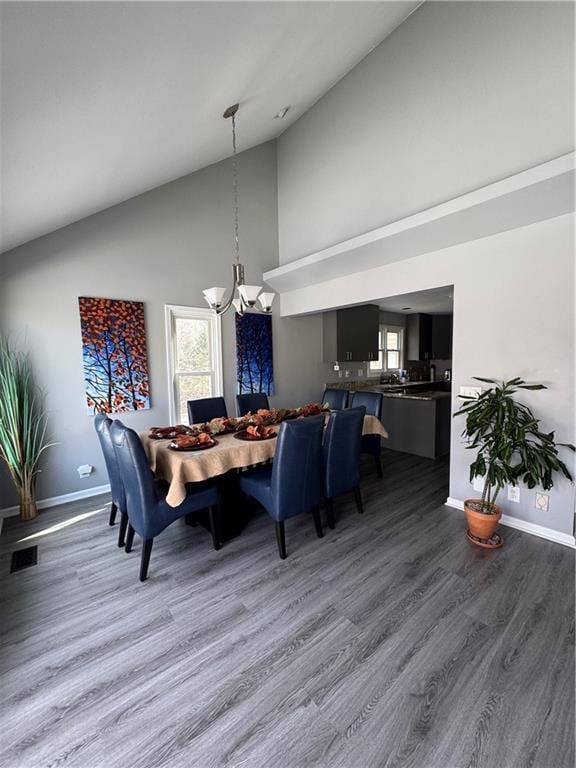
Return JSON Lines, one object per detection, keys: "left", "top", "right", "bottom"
{"left": 282, "top": 214, "right": 576, "bottom": 535}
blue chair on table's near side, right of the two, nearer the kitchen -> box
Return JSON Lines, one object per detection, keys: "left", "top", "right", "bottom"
{"left": 322, "top": 405, "right": 366, "bottom": 528}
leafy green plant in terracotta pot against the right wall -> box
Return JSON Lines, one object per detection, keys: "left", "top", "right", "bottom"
{"left": 454, "top": 376, "right": 575, "bottom": 545}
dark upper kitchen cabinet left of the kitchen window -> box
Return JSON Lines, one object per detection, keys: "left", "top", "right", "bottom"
{"left": 322, "top": 304, "right": 380, "bottom": 363}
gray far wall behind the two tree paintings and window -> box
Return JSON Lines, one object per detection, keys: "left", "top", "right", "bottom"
{"left": 0, "top": 142, "right": 322, "bottom": 509}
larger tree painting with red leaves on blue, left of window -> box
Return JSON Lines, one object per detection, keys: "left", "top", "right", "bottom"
{"left": 78, "top": 296, "right": 150, "bottom": 413}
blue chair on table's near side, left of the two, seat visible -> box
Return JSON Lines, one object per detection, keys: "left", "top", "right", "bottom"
{"left": 240, "top": 415, "right": 324, "bottom": 559}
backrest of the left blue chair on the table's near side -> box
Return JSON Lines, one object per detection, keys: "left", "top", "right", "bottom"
{"left": 269, "top": 414, "right": 324, "bottom": 520}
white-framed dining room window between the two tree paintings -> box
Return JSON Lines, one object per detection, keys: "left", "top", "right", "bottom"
{"left": 166, "top": 305, "right": 222, "bottom": 424}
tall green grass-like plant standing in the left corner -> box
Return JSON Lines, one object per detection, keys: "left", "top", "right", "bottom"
{"left": 0, "top": 339, "right": 49, "bottom": 520}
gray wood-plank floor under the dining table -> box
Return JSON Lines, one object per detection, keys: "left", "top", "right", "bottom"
{"left": 0, "top": 453, "right": 574, "bottom": 768}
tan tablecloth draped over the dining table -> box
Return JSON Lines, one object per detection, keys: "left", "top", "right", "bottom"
{"left": 140, "top": 414, "right": 388, "bottom": 507}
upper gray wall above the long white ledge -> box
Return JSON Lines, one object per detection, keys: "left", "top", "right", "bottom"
{"left": 278, "top": 2, "right": 574, "bottom": 263}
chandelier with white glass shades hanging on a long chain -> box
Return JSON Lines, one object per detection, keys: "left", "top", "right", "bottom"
{"left": 202, "top": 104, "right": 275, "bottom": 315}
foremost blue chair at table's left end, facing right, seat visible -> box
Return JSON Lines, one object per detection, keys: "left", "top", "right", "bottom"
{"left": 110, "top": 421, "right": 221, "bottom": 581}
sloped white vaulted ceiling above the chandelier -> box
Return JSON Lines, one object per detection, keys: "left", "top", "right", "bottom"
{"left": 0, "top": 1, "right": 420, "bottom": 251}
